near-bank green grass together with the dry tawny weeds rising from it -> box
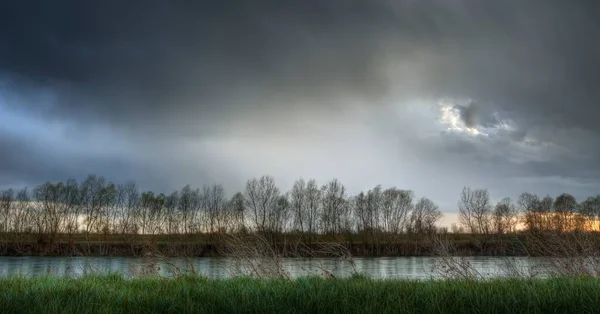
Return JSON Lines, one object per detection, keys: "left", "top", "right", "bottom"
{"left": 0, "top": 233, "right": 600, "bottom": 313}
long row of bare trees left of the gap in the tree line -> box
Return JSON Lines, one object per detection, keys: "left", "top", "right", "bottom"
{"left": 0, "top": 175, "right": 442, "bottom": 240}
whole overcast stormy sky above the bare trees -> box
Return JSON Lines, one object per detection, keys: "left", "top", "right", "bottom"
{"left": 0, "top": 0, "right": 600, "bottom": 220}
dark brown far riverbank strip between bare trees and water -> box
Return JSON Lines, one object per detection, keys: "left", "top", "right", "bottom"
{"left": 0, "top": 234, "right": 526, "bottom": 257}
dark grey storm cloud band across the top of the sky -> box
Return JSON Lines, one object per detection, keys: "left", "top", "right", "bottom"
{"left": 0, "top": 0, "right": 600, "bottom": 131}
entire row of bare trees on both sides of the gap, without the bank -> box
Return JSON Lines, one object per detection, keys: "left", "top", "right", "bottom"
{"left": 0, "top": 175, "right": 600, "bottom": 242}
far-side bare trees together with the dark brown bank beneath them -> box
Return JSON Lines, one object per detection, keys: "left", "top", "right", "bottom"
{"left": 0, "top": 175, "right": 600, "bottom": 256}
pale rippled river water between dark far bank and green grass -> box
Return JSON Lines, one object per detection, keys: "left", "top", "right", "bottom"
{"left": 0, "top": 257, "right": 541, "bottom": 279}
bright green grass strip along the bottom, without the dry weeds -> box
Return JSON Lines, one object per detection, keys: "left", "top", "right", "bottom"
{"left": 0, "top": 275, "right": 600, "bottom": 313}
